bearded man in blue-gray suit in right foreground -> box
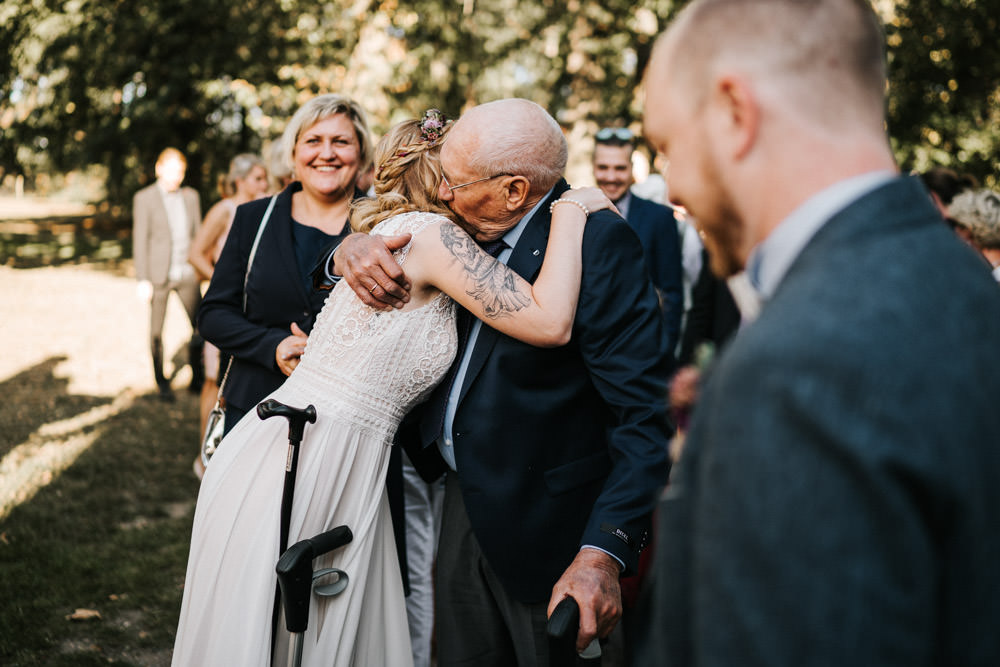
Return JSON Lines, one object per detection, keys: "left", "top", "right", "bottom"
{"left": 640, "top": 0, "right": 1000, "bottom": 667}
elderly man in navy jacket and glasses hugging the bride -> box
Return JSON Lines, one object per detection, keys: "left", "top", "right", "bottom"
{"left": 332, "top": 99, "right": 671, "bottom": 667}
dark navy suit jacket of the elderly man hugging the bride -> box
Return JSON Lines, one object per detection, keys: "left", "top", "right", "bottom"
{"left": 400, "top": 182, "right": 672, "bottom": 603}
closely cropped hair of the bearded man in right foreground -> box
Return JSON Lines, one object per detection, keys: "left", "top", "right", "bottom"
{"left": 654, "top": 0, "right": 886, "bottom": 130}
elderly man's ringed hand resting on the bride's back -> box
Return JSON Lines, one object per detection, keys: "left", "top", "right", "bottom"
{"left": 333, "top": 234, "right": 411, "bottom": 310}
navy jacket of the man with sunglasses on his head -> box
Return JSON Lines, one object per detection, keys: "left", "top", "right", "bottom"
{"left": 626, "top": 194, "right": 684, "bottom": 360}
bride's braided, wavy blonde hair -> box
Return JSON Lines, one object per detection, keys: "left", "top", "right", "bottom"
{"left": 351, "top": 119, "right": 458, "bottom": 232}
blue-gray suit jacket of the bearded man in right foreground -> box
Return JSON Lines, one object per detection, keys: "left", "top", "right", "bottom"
{"left": 639, "top": 178, "right": 1000, "bottom": 667}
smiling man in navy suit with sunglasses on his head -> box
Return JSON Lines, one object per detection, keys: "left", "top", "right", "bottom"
{"left": 593, "top": 127, "right": 684, "bottom": 360}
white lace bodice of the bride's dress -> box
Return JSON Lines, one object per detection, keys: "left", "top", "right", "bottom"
{"left": 289, "top": 212, "right": 457, "bottom": 432}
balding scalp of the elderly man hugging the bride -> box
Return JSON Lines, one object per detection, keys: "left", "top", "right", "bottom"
{"left": 458, "top": 98, "right": 569, "bottom": 193}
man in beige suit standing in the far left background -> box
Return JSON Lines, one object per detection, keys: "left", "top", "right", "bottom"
{"left": 132, "top": 148, "right": 204, "bottom": 401}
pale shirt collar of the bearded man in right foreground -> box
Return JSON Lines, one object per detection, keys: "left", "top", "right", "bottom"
{"left": 747, "top": 171, "right": 896, "bottom": 301}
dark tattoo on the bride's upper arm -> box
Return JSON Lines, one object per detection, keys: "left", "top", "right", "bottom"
{"left": 441, "top": 225, "right": 531, "bottom": 319}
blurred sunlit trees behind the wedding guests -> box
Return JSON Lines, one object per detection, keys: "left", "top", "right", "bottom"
{"left": 0, "top": 0, "right": 1000, "bottom": 213}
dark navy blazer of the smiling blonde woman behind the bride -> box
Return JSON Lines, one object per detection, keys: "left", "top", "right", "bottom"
{"left": 198, "top": 182, "right": 350, "bottom": 411}
